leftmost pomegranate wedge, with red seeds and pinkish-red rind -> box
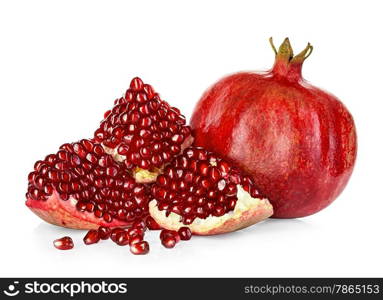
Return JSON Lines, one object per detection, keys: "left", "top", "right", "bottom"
{"left": 26, "top": 140, "right": 149, "bottom": 229}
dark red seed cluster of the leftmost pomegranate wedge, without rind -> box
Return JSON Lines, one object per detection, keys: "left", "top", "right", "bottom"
{"left": 26, "top": 139, "right": 149, "bottom": 223}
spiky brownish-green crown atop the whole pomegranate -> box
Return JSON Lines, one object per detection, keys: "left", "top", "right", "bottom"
{"left": 269, "top": 37, "right": 313, "bottom": 81}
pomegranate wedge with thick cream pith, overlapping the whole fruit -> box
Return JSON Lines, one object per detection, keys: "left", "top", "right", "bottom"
{"left": 149, "top": 147, "right": 273, "bottom": 235}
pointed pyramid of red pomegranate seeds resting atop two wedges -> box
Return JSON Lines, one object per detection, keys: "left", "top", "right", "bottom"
{"left": 94, "top": 77, "right": 191, "bottom": 170}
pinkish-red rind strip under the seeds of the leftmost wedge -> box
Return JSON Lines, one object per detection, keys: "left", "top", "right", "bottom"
{"left": 25, "top": 191, "right": 131, "bottom": 230}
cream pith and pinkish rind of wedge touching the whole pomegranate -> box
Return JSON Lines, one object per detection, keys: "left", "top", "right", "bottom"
{"left": 149, "top": 186, "right": 273, "bottom": 235}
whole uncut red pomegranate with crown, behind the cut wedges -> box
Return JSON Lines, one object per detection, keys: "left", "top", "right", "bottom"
{"left": 191, "top": 38, "right": 357, "bottom": 218}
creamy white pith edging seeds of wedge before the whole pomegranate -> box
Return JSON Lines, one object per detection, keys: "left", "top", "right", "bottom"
{"left": 149, "top": 185, "right": 272, "bottom": 234}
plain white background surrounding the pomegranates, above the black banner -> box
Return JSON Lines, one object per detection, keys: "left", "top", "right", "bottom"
{"left": 0, "top": 0, "right": 383, "bottom": 277}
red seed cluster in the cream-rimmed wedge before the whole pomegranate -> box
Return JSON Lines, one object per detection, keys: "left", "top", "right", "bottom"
{"left": 152, "top": 147, "right": 261, "bottom": 225}
